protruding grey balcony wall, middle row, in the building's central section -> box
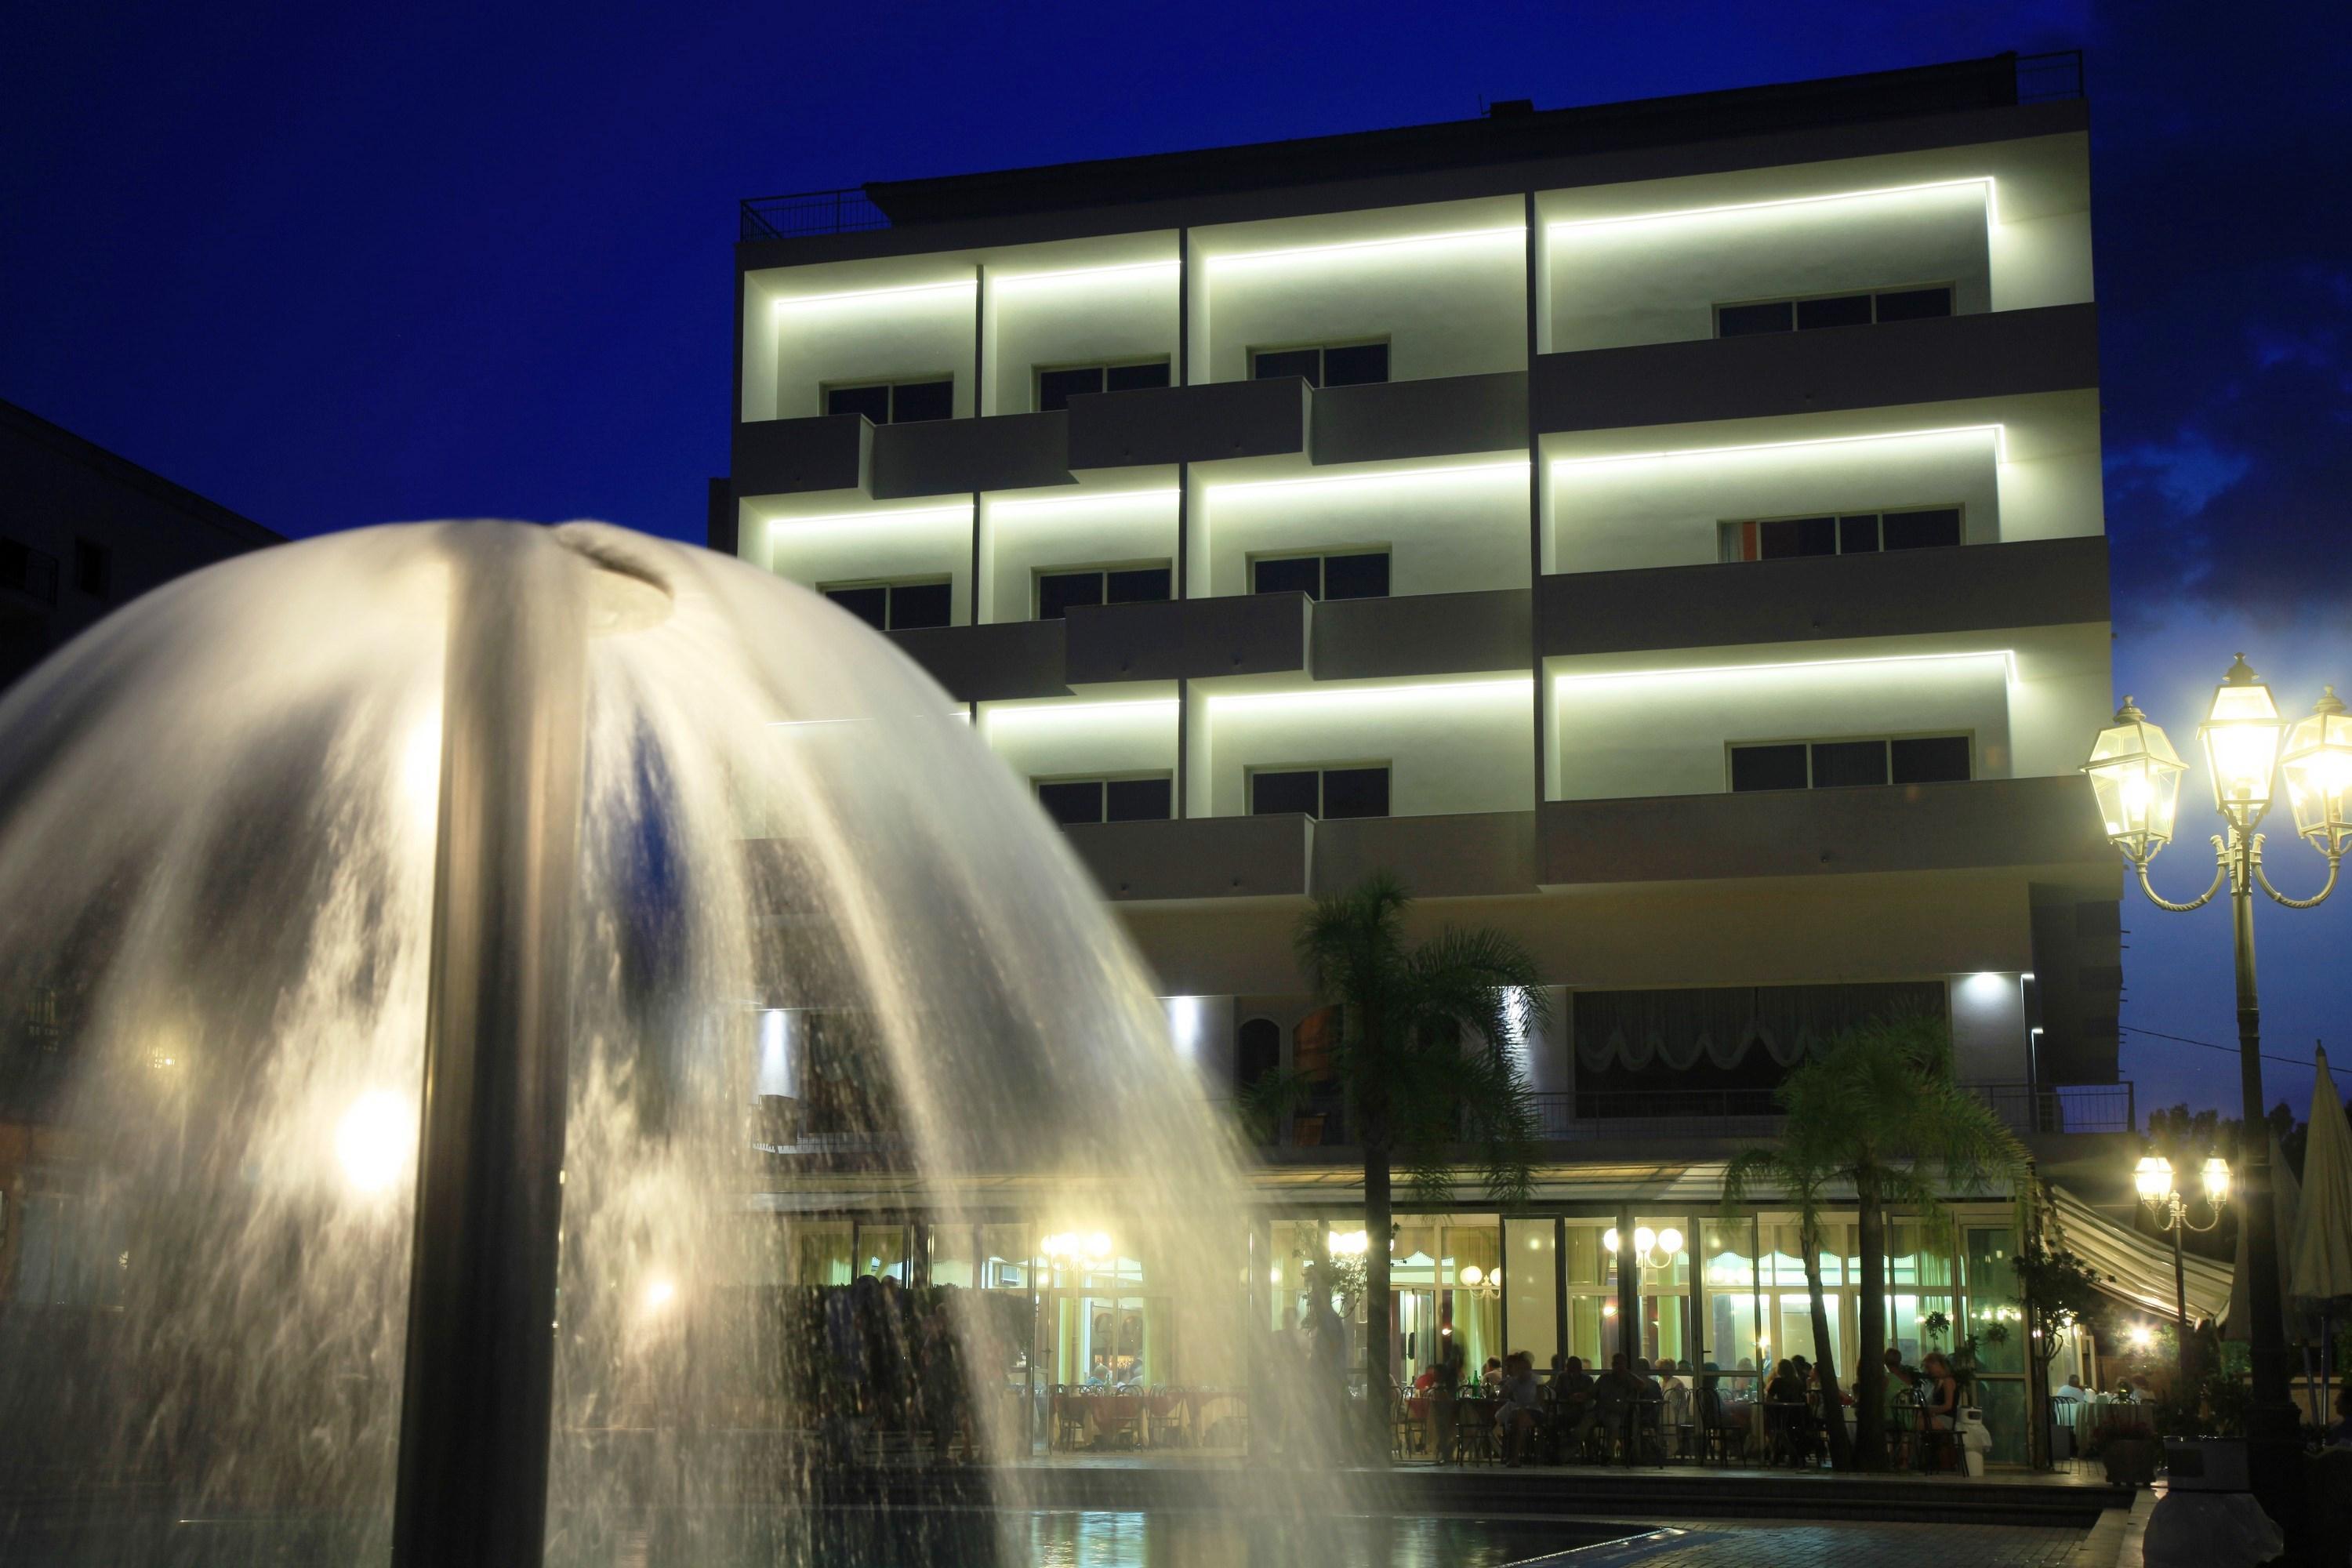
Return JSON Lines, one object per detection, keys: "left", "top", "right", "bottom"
{"left": 1068, "top": 592, "right": 1317, "bottom": 684}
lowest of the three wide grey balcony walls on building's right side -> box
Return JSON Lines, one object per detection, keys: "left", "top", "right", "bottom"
{"left": 1541, "top": 776, "right": 2114, "bottom": 886}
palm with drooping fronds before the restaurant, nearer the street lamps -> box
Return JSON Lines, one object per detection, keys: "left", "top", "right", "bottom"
{"left": 1724, "top": 1018, "right": 2032, "bottom": 1469}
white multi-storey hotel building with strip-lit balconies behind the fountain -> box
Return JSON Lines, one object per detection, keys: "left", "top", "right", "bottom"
{"left": 710, "top": 56, "right": 2131, "bottom": 1446}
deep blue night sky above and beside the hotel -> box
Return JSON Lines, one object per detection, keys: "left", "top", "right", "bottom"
{"left": 0, "top": 0, "right": 2352, "bottom": 1128}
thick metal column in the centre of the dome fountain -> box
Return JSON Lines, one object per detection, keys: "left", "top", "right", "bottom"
{"left": 393, "top": 524, "right": 588, "bottom": 1568}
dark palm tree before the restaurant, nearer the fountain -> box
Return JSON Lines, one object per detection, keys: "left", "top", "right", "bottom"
{"left": 1251, "top": 872, "right": 1550, "bottom": 1453}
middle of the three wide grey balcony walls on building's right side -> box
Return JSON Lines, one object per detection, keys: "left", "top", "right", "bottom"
{"left": 1543, "top": 536, "right": 2107, "bottom": 659}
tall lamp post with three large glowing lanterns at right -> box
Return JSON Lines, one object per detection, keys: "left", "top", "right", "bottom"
{"left": 2082, "top": 654, "right": 2352, "bottom": 1549}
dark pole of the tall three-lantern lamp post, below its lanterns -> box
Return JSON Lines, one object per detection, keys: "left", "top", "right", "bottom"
{"left": 2230, "top": 827, "right": 2303, "bottom": 1556}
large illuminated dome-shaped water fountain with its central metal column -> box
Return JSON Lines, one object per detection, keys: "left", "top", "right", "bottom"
{"left": 0, "top": 522, "right": 1338, "bottom": 1568}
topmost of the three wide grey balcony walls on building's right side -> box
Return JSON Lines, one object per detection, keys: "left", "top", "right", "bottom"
{"left": 1529, "top": 306, "right": 2098, "bottom": 433}
